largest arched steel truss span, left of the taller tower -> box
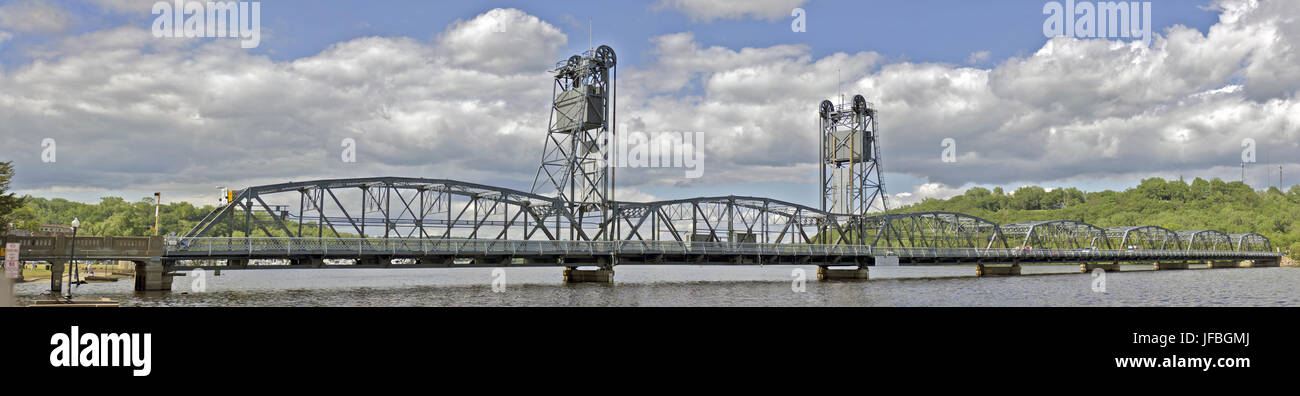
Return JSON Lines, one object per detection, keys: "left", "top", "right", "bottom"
{"left": 186, "top": 177, "right": 589, "bottom": 240}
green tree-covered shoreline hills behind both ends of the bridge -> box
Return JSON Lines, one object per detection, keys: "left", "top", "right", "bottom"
{"left": 0, "top": 162, "right": 1300, "bottom": 258}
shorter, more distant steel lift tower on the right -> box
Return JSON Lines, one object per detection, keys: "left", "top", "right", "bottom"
{"left": 818, "top": 95, "right": 889, "bottom": 216}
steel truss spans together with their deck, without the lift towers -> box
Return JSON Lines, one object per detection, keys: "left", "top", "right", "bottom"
{"left": 164, "top": 178, "right": 1279, "bottom": 269}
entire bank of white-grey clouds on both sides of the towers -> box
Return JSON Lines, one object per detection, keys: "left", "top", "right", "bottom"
{"left": 0, "top": 1, "right": 1300, "bottom": 205}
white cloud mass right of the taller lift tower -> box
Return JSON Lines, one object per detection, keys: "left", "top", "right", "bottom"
{"left": 620, "top": 1, "right": 1300, "bottom": 201}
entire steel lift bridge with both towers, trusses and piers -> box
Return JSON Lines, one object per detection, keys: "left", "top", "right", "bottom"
{"left": 10, "top": 45, "right": 1281, "bottom": 290}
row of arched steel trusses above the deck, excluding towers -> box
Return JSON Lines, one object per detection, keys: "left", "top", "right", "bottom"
{"left": 182, "top": 177, "right": 1271, "bottom": 257}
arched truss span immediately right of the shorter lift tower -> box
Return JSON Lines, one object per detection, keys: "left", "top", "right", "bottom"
{"left": 863, "top": 212, "right": 1010, "bottom": 249}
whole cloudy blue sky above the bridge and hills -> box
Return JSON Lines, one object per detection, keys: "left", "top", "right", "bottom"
{"left": 0, "top": 0, "right": 1300, "bottom": 206}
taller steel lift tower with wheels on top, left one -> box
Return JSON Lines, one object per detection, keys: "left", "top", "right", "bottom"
{"left": 532, "top": 45, "right": 618, "bottom": 239}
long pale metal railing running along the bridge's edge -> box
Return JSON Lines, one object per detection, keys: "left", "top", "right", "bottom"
{"left": 164, "top": 238, "right": 1281, "bottom": 261}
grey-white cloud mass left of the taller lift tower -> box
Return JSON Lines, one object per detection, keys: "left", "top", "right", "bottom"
{"left": 0, "top": 10, "right": 563, "bottom": 203}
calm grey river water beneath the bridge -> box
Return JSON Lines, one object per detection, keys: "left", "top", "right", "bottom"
{"left": 14, "top": 265, "right": 1300, "bottom": 306}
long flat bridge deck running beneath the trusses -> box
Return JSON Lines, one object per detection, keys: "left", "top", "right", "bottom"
{"left": 164, "top": 238, "right": 1279, "bottom": 266}
